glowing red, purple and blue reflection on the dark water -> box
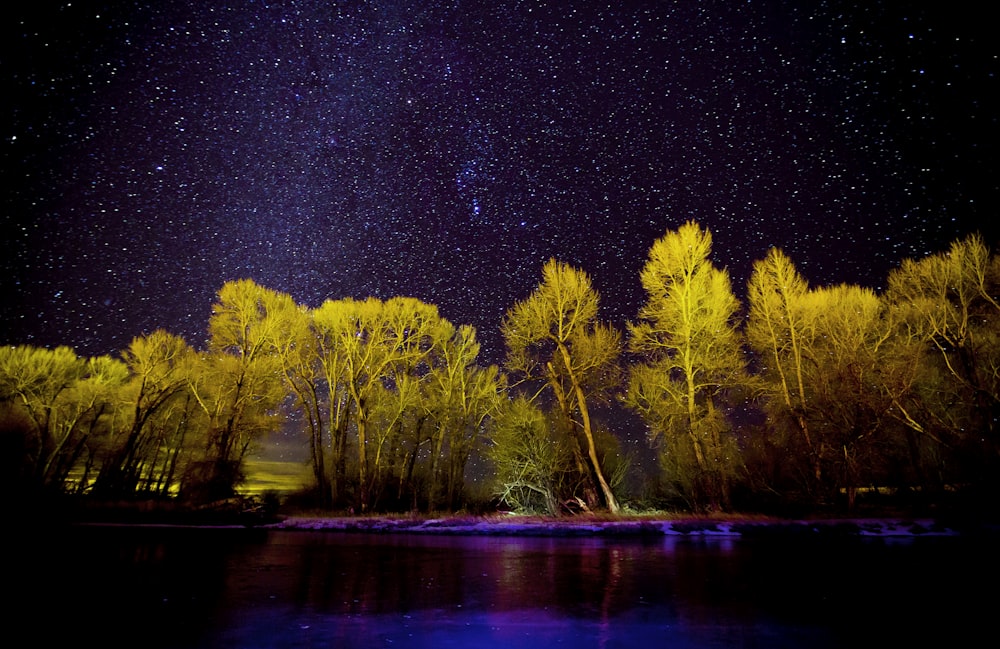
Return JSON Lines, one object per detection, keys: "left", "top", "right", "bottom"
{"left": 215, "top": 533, "right": 768, "bottom": 647}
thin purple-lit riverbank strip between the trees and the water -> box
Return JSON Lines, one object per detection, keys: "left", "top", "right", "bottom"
{"left": 21, "top": 500, "right": 1000, "bottom": 538}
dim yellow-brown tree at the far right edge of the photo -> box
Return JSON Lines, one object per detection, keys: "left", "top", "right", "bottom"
{"left": 886, "top": 235, "right": 1000, "bottom": 481}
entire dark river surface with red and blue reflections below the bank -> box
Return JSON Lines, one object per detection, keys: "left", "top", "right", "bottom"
{"left": 11, "top": 527, "right": 1000, "bottom": 649}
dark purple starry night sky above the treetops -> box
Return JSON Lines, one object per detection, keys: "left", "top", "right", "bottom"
{"left": 0, "top": 0, "right": 1000, "bottom": 362}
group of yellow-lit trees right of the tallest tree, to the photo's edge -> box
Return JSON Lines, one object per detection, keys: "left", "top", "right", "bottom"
{"left": 747, "top": 237, "right": 1000, "bottom": 506}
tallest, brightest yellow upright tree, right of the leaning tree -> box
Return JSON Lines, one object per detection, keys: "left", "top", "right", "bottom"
{"left": 626, "top": 222, "right": 750, "bottom": 508}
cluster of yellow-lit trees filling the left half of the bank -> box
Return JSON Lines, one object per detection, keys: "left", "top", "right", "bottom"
{"left": 0, "top": 280, "right": 502, "bottom": 510}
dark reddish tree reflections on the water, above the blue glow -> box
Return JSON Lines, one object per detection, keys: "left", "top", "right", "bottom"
{"left": 221, "top": 532, "right": 780, "bottom": 624}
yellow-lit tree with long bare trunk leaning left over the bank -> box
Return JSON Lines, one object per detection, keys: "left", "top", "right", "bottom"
{"left": 502, "top": 259, "right": 621, "bottom": 512}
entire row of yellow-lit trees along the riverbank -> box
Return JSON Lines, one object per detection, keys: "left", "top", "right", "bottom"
{"left": 0, "top": 222, "right": 1000, "bottom": 514}
